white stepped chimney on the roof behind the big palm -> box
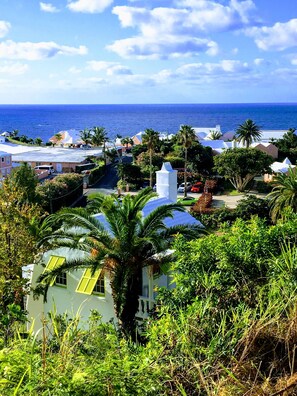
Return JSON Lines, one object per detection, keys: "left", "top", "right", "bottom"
{"left": 156, "top": 162, "right": 177, "bottom": 202}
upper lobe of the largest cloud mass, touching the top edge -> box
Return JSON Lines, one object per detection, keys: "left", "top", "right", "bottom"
{"left": 113, "top": 0, "right": 254, "bottom": 36}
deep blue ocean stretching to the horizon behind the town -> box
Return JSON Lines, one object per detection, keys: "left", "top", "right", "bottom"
{"left": 0, "top": 103, "right": 297, "bottom": 141}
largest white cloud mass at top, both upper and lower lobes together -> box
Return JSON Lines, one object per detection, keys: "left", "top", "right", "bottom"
{"left": 107, "top": 0, "right": 254, "bottom": 59}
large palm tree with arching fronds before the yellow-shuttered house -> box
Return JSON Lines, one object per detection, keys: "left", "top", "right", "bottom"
{"left": 37, "top": 188, "right": 201, "bottom": 338}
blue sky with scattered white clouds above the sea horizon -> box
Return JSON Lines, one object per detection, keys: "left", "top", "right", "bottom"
{"left": 0, "top": 0, "right": 297, "bottom": 104}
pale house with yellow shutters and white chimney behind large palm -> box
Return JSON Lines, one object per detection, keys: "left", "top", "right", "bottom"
{"left": 26, "top": 163, "right": 201, "bottom": 331}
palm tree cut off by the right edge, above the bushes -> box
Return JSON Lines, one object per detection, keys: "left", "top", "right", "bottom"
{"left": 268, "top": 167, "right": 297, "bottom": 222}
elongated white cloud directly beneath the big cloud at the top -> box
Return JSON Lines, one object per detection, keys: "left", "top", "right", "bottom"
{"left": 107, "top": 35, "right": 218, "bottom": 59}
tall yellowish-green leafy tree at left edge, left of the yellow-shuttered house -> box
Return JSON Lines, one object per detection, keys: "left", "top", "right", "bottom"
{"left": 0, "top": 178, "right": 41, "bottom": 342}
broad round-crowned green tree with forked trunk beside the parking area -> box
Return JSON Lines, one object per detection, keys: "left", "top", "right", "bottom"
{"left": 214, "top": 148, "right": 273, "bottom": 192}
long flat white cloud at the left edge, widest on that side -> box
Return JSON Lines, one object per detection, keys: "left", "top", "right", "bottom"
{"left": 0, "top": 40, "right": 87, "bottom": 60}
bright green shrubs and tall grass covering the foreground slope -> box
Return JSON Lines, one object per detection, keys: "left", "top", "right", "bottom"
{"left": 0, "top": 215, "right": 297, "bottom": 396}
